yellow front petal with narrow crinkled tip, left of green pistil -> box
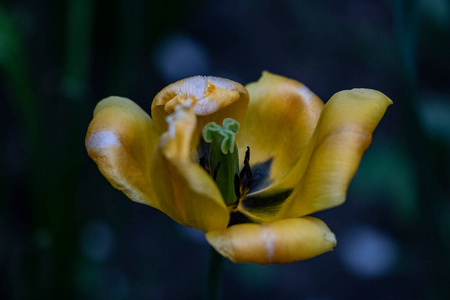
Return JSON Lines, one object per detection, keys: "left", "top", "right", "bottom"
{"left": 151, "top": 106, "right": 229, "bottom": 231}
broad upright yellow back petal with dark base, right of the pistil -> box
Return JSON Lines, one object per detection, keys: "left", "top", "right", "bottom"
{"left": 238, "top": 72, "right": 323, "bottom": 191}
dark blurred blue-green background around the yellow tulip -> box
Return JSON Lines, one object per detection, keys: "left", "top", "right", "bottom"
{"left": 0, "top": 0, "right": 450, "bottom": 300}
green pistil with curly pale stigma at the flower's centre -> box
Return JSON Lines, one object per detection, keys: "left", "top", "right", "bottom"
{"left": 203, "top": 118, "right": 240, "bottom": 205}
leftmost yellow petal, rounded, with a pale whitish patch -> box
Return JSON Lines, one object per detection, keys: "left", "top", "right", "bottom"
{"left": 85, "top": 97, "right": 159, "bottom": 208}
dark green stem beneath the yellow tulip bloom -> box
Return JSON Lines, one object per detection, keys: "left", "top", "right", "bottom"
{"left": 206, "top": 247, "right": 223, "bottom": 300}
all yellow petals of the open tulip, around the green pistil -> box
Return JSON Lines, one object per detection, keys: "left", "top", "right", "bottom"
{"left": 86, "top": 72, "right": 392, "bottom": 264}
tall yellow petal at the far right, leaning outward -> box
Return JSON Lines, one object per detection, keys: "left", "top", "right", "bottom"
{"left": 275, "top": 89, "right": 392, "bottom": 218}
